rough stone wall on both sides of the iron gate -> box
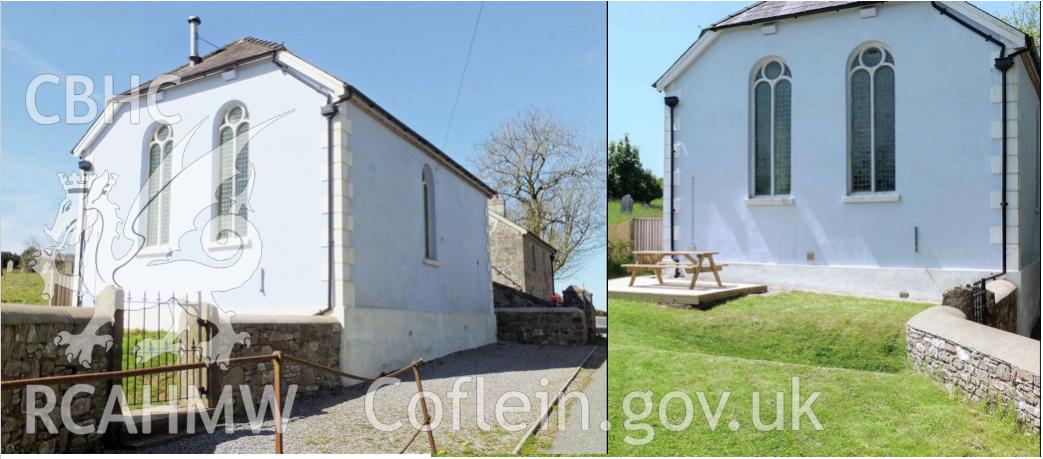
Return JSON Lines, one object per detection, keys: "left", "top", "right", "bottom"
{"left": 0, "top": 304, "right": 341, "bottom": 454}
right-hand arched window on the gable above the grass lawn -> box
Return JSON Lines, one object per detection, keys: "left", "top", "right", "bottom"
{"left": 848, "top": 45, "right": 895, "bottom": 193}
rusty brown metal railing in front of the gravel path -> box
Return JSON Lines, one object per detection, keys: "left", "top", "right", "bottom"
{"left": 0, "top": 351, "right": 438, "bottom": 455}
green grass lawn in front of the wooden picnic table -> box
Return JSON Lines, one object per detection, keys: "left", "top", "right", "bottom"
{"left": 608, "top": 292, "right": 1040, "bottom": 456}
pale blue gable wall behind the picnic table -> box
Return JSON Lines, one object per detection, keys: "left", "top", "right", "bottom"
{"left": 663, "top": 2, "right": 1039, "bottom": 310}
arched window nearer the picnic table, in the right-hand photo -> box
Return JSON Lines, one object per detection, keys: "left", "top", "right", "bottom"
{"left": 753, "top": 59, "right": 793, "bottom": 196}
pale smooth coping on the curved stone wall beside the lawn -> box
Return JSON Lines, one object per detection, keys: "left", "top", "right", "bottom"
{"left": 906, "top": 306, "right": 1040, "bottom": 376}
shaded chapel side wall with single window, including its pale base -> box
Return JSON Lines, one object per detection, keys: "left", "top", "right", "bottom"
{"left": 341, "top": 102, "right": 495, "bottom": 375}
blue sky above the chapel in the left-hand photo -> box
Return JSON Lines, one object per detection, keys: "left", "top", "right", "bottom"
{"left": 0, "top": 2, "right": 606, "bottom": 307}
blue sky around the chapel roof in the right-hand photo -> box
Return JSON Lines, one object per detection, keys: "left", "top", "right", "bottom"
{"left": 608, "top": 2, "right": 1020, "bottom": 176}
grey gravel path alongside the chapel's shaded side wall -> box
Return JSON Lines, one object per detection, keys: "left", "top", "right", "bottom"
{"left": 121, "top": 343, "right": 591, "bottom": 454}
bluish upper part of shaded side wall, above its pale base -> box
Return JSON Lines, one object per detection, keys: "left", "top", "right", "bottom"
{"left": 348, "top": 104, "right": 492, "bottom": 312}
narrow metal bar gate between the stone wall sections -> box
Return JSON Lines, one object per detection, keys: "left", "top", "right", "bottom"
{"left": 114, "top": 292, "right": 212, "bottom": 411}
